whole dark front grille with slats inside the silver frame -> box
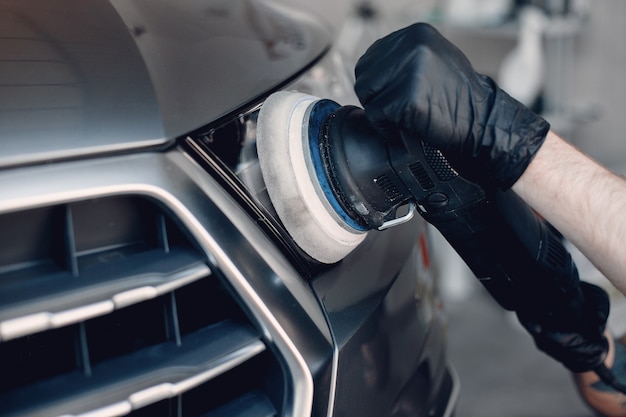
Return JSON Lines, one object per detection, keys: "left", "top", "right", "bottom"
{"left": 0, "top": 196, "right": 285, "bottom": 417}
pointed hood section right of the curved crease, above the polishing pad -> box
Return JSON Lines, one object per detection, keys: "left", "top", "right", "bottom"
{"left": 113, "top": 0, "right": 330, "bottom": 137}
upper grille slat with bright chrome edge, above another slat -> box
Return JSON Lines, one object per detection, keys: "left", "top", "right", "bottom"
{"left": 0, "top": 251, "right": 210, "bottom": 340}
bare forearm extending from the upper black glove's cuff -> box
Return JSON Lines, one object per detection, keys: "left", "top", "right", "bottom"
{"left": 513, "top": 132, "right": 626, "bottom": 293}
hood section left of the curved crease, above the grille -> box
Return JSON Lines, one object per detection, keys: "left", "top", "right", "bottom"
{"left": 0, "top": 0, "right": 166, "bottom": 167}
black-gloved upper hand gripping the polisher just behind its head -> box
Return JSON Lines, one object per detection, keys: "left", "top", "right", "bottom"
{"left": 354, "top": 23, "right": 550, "bottom": 189}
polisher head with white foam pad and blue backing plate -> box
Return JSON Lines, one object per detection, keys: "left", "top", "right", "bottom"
{"left": 257, "top": 91, "right": 413, "bottom": 263}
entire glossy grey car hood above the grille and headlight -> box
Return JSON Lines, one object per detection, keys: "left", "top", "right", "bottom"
{"left": 0, "top": 0, "right": 330, "bottom": 167}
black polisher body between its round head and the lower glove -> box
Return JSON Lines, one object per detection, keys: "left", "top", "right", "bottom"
{"left": 387, "top": 133, "right": 582, "bottom": 311}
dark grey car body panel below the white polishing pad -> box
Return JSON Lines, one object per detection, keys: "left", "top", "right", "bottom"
{"left": 312, "top": 220, "right": 452, "bottom": 416}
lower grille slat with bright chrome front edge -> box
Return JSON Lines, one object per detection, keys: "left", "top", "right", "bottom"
{"left": 0, "top": 322, "right": 265, "bottom": 417}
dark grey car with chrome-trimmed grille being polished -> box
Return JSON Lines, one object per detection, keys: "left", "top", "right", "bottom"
{"left": 0, "top": 0, "right": 459, "bottom": 417}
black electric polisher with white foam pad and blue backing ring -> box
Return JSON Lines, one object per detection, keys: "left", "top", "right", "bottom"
{"left": 257, "top": 91, "right": 624, "bottom": 390}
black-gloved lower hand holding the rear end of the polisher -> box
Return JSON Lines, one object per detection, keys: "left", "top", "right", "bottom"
{"left": 516, "top": 282, "right": 609, "bottom": 372}
